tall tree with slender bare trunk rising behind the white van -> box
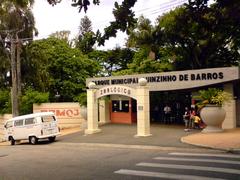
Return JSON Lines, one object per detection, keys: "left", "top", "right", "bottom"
{"left": 0, "top": 0, "right": 34, "bottom": 116}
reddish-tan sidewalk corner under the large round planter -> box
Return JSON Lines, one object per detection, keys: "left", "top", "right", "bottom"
{"left": 181, "top": 128, "right": 240, "bottom": 153}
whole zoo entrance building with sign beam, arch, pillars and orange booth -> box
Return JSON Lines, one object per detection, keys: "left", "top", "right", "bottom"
{"left": 85, "top": 67, "right": 240, "bottom": 136}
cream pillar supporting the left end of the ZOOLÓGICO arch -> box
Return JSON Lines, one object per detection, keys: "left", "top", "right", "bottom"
{"left": 85, "top": 83, "right": 101, "bottom": 134}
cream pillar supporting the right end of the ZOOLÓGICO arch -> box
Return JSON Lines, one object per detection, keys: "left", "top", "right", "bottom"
{"left": 136, "top": 79, "right": 151, "bottom": 137}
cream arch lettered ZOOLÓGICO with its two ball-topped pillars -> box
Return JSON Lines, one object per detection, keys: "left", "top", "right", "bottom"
{"left": 85, "top": 78, "right": 151, "bottom": 136}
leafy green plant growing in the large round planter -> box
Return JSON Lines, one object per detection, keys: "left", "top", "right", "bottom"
{"left": 194, "top": 88, "right": 231, "bottom": 108}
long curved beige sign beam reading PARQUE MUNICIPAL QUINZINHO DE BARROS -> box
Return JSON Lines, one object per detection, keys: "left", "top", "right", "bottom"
{"left": 86, "top": 67, "right": 239, "bottom": 91}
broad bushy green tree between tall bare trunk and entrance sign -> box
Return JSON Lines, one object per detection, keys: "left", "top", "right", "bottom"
{"left": 23, "top": 37, "right": 100, "bottom": 102}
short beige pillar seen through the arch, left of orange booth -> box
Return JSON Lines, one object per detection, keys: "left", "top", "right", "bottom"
{"left": 99, "top": 99, "right": 110, "bottom": 124}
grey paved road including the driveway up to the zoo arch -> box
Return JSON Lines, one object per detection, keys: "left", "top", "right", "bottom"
{"left": 0, "top": 125, "right": 240, "bottom": 180}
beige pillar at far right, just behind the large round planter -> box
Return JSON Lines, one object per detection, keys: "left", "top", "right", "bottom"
{"left": 222, "top": 83, "right": 237, "bottom": 129}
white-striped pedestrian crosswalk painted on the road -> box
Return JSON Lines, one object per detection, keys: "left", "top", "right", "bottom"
{"left": 114, "top": 152, "right": 240, "bottom": 180}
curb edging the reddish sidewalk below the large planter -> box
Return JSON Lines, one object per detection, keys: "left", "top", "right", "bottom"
{"left": 181, "top": 137, "right": 240, "bottom": 154}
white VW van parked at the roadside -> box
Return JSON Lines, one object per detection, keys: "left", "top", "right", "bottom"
{"left": 4, "top": 112, "right": 60, "bottom": 145}
